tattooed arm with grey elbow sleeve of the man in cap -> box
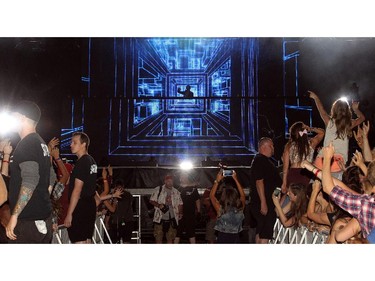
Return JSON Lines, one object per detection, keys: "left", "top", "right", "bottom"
{"left": 6, "top": 161, "right": 39, "bottom": 240}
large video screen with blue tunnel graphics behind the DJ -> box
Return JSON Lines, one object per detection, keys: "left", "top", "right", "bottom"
{"left": 62, "top": 38, "right": 258, "bottom": 162}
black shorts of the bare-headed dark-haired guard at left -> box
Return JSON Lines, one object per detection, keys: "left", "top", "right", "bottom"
{"left": 67, "top": 197, "right": 96, "bottom": 243}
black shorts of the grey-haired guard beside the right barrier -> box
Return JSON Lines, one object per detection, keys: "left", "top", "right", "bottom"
{"left": 250, "top": 202, "right": 276, "bottom": 239}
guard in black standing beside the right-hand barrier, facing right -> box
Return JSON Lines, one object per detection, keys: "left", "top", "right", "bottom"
{"left": 250, "top": 138, "right": 282, "bottom": 244}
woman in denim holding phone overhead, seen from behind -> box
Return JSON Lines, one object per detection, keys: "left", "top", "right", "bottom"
{"left": 210, "top": 168, "right": 245, "bottom": 244}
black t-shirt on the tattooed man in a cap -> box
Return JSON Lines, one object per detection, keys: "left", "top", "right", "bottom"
{"left": 9, "top": 133, "right": 52, "bottom": 220}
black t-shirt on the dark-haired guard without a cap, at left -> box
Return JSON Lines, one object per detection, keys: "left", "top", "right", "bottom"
{"left": 68, "top": 154, "right": 98, "bottom": 200}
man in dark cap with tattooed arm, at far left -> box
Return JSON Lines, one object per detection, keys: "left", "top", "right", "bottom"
{"left": 6, "top": 101, "right": 56, "bottom": 243}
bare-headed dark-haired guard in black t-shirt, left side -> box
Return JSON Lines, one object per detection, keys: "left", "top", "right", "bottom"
{"left": 64, "top": 132, "right": 98, "bottom": 244}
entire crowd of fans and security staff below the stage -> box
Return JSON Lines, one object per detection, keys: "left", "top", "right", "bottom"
{"left": 0, "top": 91, "right": 375, "bottom": 244}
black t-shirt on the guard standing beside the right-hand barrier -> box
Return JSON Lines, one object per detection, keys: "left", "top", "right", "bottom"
{"left": 250, "top": 153, "right": 282, "bottom": 206}
